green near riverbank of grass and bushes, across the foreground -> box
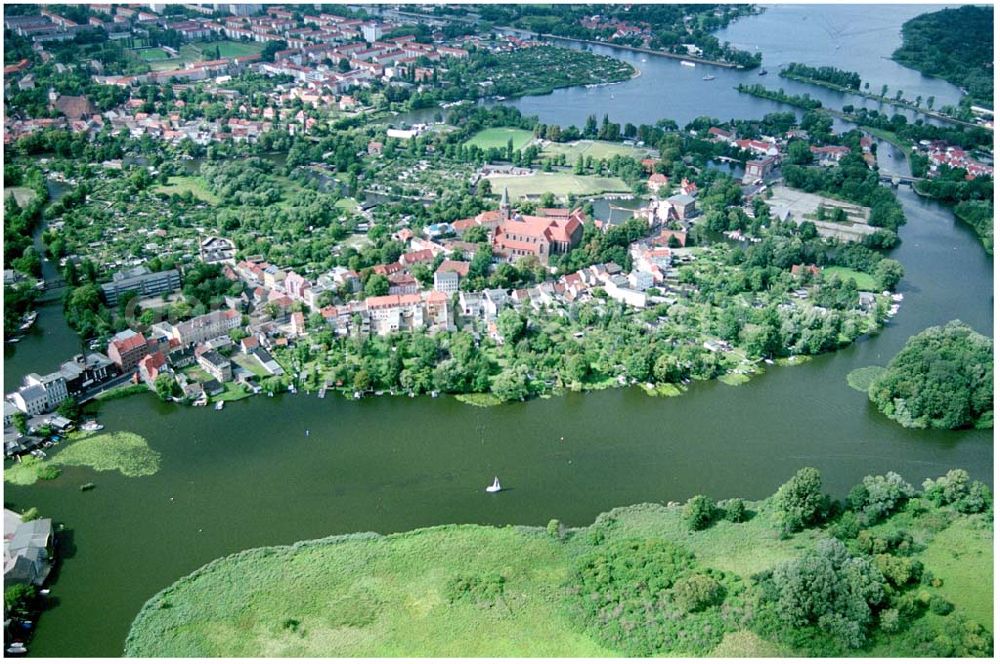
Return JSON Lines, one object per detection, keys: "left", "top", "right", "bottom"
{"left": 125, "top": 472, "right": 993, "bottom": 657}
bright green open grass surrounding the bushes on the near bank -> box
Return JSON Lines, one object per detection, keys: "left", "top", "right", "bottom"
{"left": 126, "top": 488, "right": 993, "bottom": 657}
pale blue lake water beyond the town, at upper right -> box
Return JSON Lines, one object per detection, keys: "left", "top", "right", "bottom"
{"left": 395, "top": 5, "right": 960, "bottom": 131}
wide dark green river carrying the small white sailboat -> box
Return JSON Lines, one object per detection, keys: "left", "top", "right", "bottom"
{"left": 5, "top": 7, "right": 993, "bottom": 656}
